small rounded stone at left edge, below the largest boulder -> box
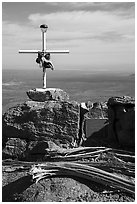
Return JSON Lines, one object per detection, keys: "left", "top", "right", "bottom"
{"left": 2, "top": 138, "right": 27, "bottom": 159}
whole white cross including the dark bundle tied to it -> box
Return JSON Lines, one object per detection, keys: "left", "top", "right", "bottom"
{"left": 19, "top": 24, "right": 69, "bottom": 89}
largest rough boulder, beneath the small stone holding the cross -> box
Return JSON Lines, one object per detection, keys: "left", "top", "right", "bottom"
{"left": 3, "top": 101, "right": 79, "bottom": 147}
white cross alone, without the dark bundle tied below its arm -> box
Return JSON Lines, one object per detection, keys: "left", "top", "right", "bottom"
{"left": 19, "top": 24, "right": 69, "bottom": 89}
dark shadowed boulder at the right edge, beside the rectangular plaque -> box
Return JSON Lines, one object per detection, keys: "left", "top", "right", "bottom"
{"left": 108, "top": 96, "right": 135, "bottom": 150}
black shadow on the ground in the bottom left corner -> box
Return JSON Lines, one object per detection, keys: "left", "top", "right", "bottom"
{"left": 2, "top": 176, "right": 33, "bottom": 202}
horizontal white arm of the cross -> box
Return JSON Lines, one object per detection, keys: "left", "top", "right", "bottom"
{"left": 19, "top": 50, "right": 69, "bottom": 54}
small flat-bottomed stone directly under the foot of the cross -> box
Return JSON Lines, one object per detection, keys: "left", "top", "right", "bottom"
{"left": 27, "top": 88, "right": 69, "bottom": 102}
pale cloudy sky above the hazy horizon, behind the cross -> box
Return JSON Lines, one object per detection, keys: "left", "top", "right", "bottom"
{"left": 2, "top": 2, "right": 135, "bottom": 72}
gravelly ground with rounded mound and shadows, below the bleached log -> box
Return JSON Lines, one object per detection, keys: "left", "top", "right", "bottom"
{"left": 2, "top": 168, "right": 134, "bottom": 202}
